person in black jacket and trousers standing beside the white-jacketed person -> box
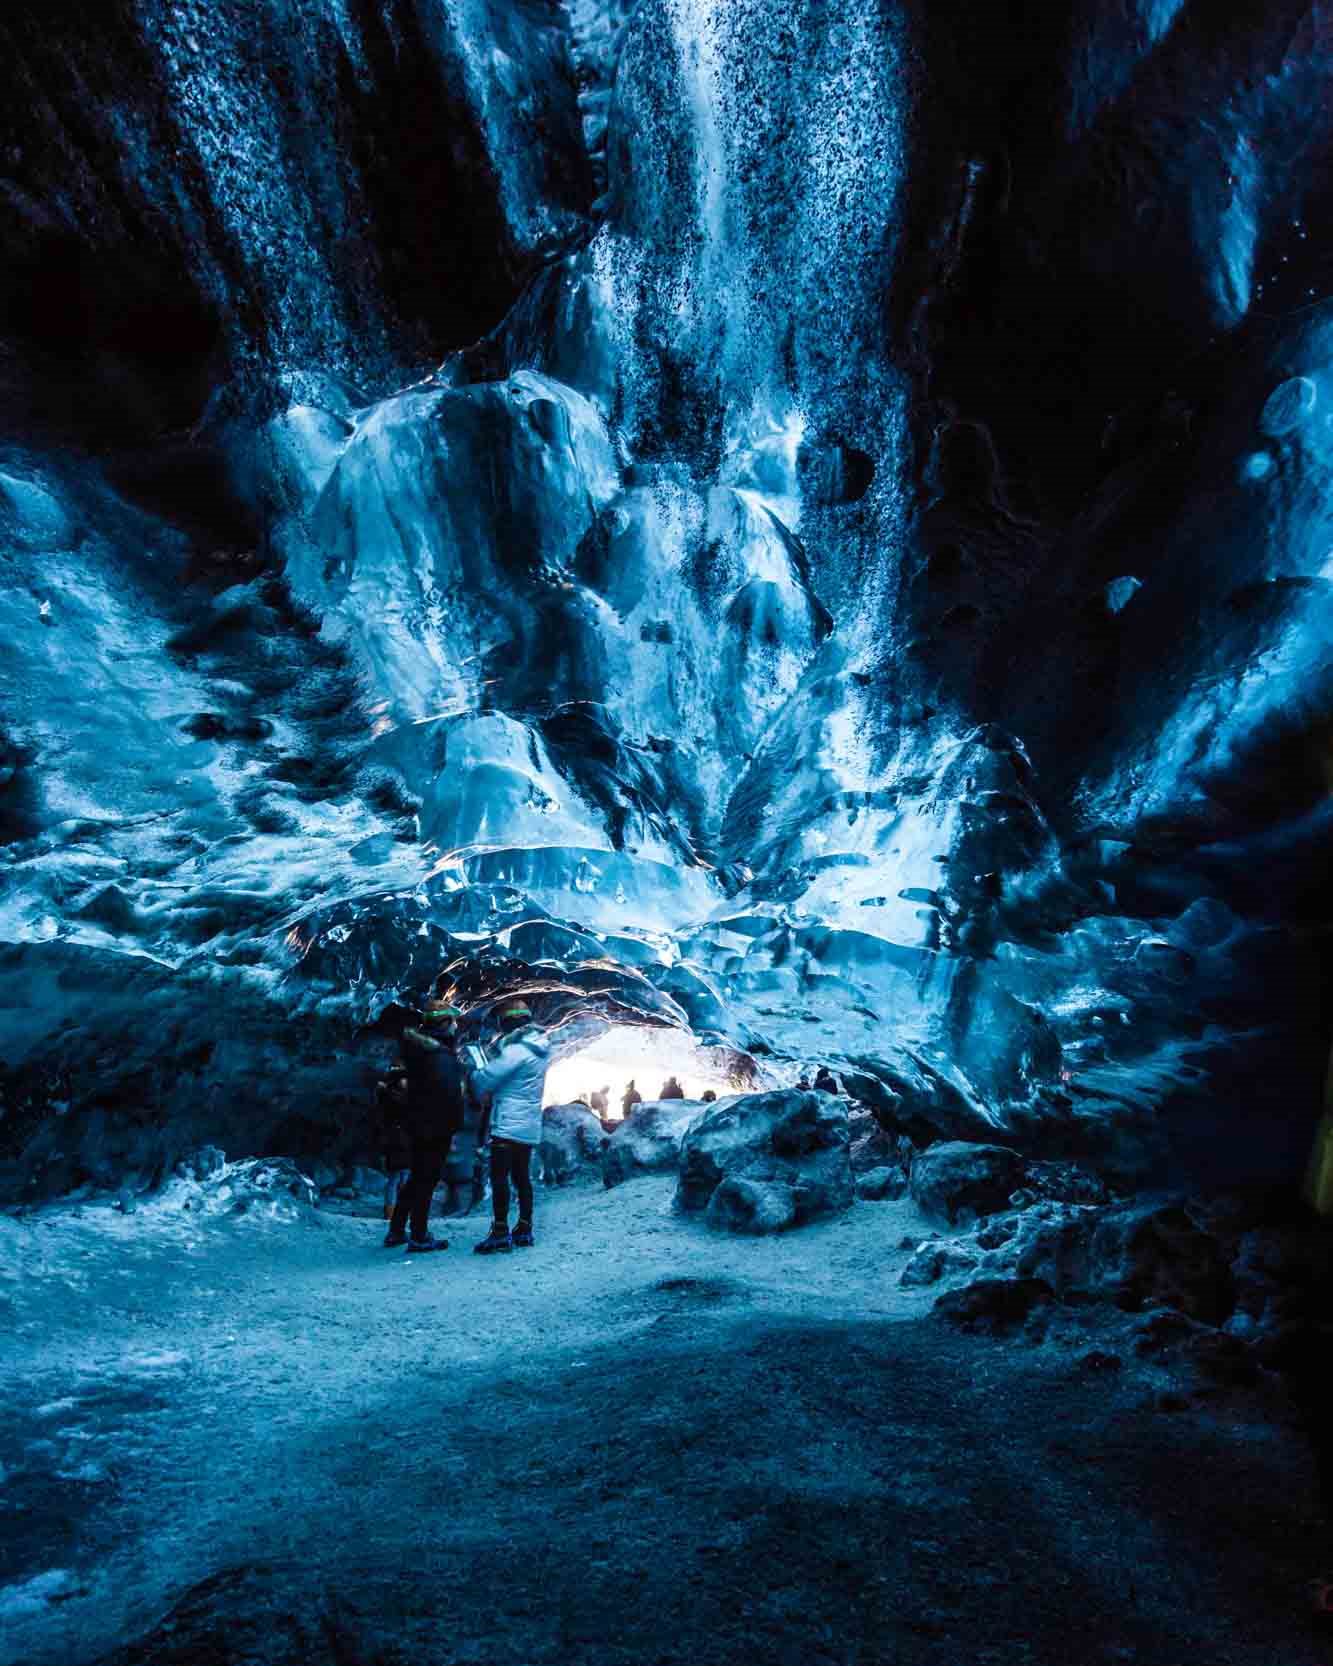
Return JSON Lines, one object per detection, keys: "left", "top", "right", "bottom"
{"left": 385, "top": 996, "right": 465, "bottom": 1254}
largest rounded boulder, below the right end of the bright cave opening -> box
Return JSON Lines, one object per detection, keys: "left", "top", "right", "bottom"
{"left": 675, "top": 1090, "right": 853, "bottom": 1233}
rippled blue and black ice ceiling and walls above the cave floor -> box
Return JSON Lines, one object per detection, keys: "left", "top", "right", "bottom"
{"left": 0, "top": 0, "right": 1333, "bottom": 1195}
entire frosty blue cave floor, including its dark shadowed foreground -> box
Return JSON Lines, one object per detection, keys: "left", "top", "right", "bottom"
{"left": 0, "top": 1176, "right": 1333, "bottom": 1666}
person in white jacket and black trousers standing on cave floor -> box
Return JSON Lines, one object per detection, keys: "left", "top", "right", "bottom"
{"left": 472, "top": 1001, "right": 552, "bottom": 1254}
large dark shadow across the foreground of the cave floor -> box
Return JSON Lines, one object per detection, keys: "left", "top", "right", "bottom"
{"left": 88, "top": 1312, "right": 1323, "bottom": 1666}
